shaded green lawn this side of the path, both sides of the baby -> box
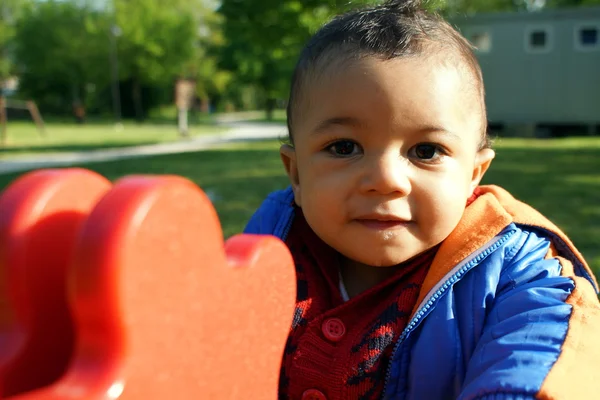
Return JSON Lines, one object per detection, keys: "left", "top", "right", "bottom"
{"left": 0, "top": 138, "right": 600, "bottom": 276}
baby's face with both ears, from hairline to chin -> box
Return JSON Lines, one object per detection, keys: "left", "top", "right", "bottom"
{"left": 281, "top": 54, "right": 494, "bottom": 266}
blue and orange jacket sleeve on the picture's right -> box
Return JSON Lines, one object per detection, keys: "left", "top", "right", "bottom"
{"left": 459, "top": 228, "right": 600, "bottom": 400}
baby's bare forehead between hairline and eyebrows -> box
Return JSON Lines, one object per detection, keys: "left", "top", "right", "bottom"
{"left": 298, "top": 56, "right": 481, "bottom": 137}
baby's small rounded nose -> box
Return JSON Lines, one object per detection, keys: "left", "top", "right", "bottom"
{"left": 362, "top": 152, "right": 411, "bottom": 195}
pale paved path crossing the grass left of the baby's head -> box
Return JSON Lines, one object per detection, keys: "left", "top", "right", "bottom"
{"left": 0, "top": 121, "right": 287, "bottom": 175}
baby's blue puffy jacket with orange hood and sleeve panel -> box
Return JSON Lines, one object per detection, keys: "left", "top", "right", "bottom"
{"left": 245, "top": 186, "right": 600, "bottom": 400}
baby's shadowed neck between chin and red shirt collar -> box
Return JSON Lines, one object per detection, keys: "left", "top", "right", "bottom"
{"left": 340, "top": 257, "right": 398, "bottom": 298}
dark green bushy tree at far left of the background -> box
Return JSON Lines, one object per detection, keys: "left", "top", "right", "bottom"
{"left": 14, "top": 0, "right": 109, "bottom": 113}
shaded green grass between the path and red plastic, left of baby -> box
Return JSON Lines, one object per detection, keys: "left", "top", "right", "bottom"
{"left": 0, "top": 141, "right": 287, "bottom": 236}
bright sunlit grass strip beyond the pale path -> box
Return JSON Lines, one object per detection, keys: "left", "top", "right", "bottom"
{"left": 0, "top": 122, "right": 225, "bottom": 160}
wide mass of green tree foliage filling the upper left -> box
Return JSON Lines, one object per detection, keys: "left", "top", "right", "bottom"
{"left": 10, "top": 0, "right": 220, "bottom": 118}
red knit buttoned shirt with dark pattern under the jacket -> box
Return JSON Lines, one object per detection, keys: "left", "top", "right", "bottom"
{"left": 279, "top": 208, "right": 437, "bottom": 400}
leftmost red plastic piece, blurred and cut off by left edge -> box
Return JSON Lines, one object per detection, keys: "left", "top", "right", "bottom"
{"left": 0, "top": 169, "right": 111, "bottom": 397}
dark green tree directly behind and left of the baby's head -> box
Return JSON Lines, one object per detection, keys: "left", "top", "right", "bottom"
{"left": 219, "top": 0, "right": 378, "bottom": 119}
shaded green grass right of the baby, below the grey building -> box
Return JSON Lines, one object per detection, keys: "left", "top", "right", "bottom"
{"left": 484, "top": 137, "right": 600, "bottom": 278}
